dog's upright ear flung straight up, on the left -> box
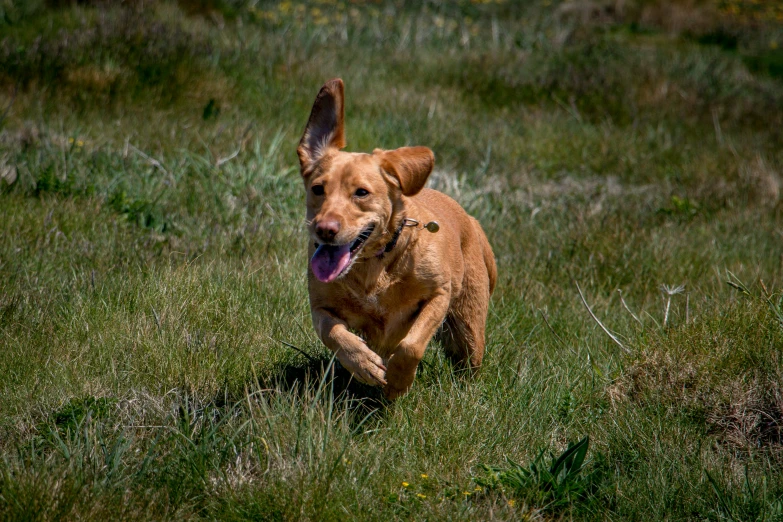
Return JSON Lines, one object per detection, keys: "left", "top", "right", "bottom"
{"left": 296, "top": 78, "right": 345, "bottom": 176}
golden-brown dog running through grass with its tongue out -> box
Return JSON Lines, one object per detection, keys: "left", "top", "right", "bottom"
{"left": 297, "top": 78, "right": 497, "bottom": 400}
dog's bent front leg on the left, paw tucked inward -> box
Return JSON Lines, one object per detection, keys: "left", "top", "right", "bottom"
{"left": 312, "top": 308, "right": 386, "bottom": 386}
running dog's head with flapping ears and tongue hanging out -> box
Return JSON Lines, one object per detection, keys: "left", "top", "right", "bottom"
{"left": 297, "top": 79, "right": 435, "bottom": 283}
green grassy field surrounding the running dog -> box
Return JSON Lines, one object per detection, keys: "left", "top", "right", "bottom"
{"left": 0, "top": 0, "right": 783, "bottom": 521}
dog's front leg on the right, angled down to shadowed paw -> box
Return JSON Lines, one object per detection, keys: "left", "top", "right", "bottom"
{"left": 383, "top": 291, "right": 451, "bottom": 399}
